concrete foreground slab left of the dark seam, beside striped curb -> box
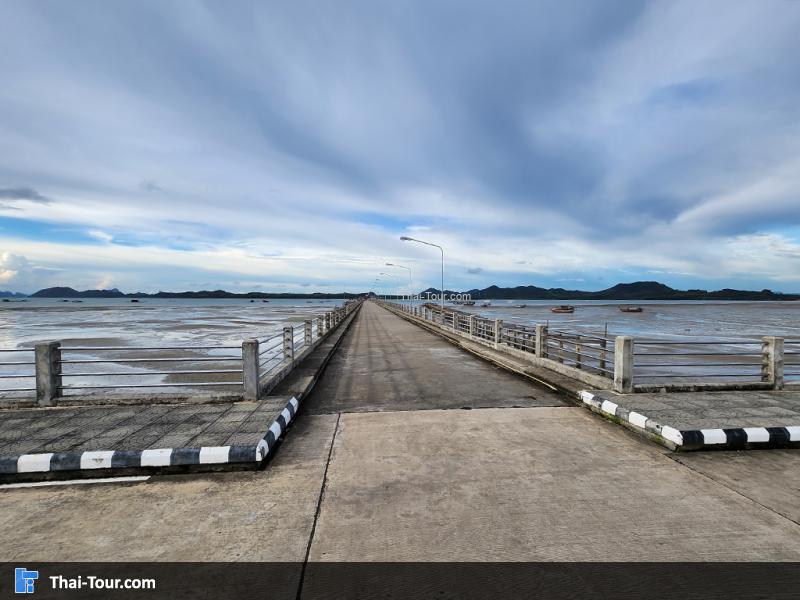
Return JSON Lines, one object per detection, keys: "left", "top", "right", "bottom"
{"left": 0, "top": 416, "right": 336, "bottom": 560}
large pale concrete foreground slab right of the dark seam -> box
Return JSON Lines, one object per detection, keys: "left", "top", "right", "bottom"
{"left": 310, "top": 407, "right": 800, "bottom": 561}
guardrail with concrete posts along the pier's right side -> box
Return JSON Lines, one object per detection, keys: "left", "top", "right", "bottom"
{"left": 383, "top": 302, "right": 800, "bottom": 392}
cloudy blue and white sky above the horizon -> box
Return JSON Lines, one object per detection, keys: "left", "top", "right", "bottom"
{"left": 0, "top": 0, "right": 800, "bottom": 292}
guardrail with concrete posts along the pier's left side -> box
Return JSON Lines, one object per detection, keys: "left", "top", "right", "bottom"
{"left": 0, "top": 301, "right": 360, "bottom": 406}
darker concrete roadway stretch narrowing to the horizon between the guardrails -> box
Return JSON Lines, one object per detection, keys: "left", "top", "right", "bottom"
{"left": 303, "top": 302, "right": 564, "bottom": 414}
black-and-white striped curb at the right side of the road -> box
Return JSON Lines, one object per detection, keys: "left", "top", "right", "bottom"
{"left": 580, "top": 391, "right": 800, "bottom": 450}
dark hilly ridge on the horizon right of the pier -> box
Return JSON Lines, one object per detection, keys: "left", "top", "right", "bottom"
{"left": 423, "top": 281, "right": 800, "bottom": 301}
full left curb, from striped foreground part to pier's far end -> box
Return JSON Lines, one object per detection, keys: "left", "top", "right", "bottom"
{"left": 0, "top": 306, "right": 361, "bottom": 482}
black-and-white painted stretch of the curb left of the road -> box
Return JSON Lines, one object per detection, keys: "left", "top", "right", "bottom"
{"left": 0, "top": 397, "right": 300, "bottom": 475}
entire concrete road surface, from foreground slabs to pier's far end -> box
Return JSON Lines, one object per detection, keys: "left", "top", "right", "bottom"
{"left": 0, "top": 303, "right": 800, "bottom": 568}
